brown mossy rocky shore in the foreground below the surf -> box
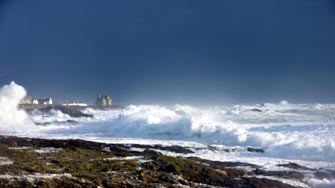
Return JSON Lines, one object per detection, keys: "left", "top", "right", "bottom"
{"left": 0, "top": 136, "right": 318, "bottom": 188}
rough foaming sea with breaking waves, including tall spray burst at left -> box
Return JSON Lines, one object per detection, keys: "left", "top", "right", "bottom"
{"left": 0, "top": 83, "right": 335, "bottom": 187}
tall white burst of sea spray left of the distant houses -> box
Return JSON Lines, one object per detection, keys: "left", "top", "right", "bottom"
{"left": 0, "top": 82, "right": 33, "bottom": 134}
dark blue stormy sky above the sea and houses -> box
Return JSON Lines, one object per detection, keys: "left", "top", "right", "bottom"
{"left": 0, "top": 0, "right": 335, "bottom": 104}
